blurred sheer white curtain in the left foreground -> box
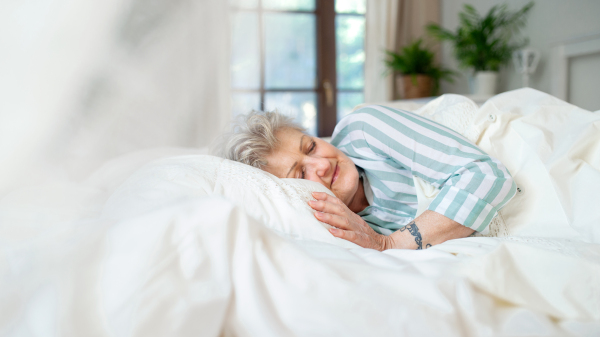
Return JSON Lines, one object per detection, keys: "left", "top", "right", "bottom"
{"left": 0, "top": 0, "right": 230, "bottom": 197}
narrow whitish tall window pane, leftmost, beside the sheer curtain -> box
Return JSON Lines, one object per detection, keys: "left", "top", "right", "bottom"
{"left": 231, "top": 12, "right": 260, "bottom": 89}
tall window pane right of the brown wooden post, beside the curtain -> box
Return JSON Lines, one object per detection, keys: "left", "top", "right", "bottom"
{"left": 335, "top": 15, "right": 365, "bottom": 89}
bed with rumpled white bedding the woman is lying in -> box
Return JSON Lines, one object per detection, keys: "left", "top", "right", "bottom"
{"left": 0, "top": 89, "right": 600, "bottom": 336}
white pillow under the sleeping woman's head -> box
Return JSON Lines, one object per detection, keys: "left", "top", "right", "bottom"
{"left": 103, "top": 155, "right": 358, "bottom": 248}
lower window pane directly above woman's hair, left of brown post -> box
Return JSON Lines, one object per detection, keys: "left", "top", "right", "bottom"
{"left": 265, "top": 92, "right": 317, "bottom": 136}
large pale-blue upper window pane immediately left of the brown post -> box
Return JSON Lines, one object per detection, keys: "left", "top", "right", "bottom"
{"left": 264, "top": 13, "right": 317, "bottom": 89}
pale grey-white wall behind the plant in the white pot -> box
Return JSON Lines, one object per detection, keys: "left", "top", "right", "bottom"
{"left": 441, "top": 0, "right": 600, "bottom": 110}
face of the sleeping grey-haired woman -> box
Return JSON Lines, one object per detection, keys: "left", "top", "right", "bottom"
{"left": 264, "top": 128, "right": 359, "bottom": 205}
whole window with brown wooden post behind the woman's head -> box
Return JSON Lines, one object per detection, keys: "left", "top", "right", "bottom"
{"left": 231, "top": 0, "right": 366, "bottom": 136}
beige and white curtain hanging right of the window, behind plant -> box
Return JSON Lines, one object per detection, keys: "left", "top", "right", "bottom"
{"left": 365, "top": 0, "right": 440, "bottom": 103}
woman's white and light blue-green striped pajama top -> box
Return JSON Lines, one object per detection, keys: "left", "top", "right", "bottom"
{"left": 331, "top": 105, "right": 516, "bottom": 234}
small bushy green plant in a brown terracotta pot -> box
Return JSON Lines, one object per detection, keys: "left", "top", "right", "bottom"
{"left": 385, "top": 39, "right": 454, "bottom": 99}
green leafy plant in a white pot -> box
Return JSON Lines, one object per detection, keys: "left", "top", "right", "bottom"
{"left": 427, "top": 2, "right": 533, "bottom": 95}
